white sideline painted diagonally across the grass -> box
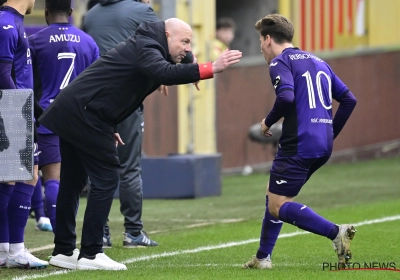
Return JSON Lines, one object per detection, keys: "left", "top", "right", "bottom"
{"left": 13, "top": 215, "right": 400, "bottom": 280}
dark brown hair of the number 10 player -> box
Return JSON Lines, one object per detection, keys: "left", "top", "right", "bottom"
{"left": 255, "top": 14, "right": 294, "bottom": 44}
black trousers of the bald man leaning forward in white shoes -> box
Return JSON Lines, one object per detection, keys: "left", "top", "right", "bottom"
{"left": 54, "top": 138, "right": 119, "bottom": 256}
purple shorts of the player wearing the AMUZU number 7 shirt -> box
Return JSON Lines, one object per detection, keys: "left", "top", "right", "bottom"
{"left": 38, "top": 133, "right": 61, "bottom": 169}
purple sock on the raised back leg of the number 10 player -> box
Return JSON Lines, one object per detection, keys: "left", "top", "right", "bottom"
{"left": 279, "top": 202, "right": 339, "bottom": 240}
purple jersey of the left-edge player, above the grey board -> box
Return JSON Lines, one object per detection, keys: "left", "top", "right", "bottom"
{"left": 0, "top": 6, "right": 33, "bottom": 89}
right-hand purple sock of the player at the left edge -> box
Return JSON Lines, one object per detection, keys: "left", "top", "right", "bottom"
{"left": 8, "top": 182, "right": 35, "bottom": 244}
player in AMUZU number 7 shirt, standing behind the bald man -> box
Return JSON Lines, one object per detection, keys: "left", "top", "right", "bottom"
{"left": 29, "top": 0, "right": 99, "bottom": 233}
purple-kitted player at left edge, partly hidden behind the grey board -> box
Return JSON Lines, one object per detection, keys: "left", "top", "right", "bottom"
{"left": 0, "top": 0, "right": 48, "bottom": 268}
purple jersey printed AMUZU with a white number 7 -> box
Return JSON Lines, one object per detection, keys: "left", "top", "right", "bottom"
{"left": 29, "top": 23, "right": 99, "bottom": 134}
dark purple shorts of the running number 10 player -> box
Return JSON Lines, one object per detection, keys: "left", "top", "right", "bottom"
{"left": 269, "top": 155, "right": 329, "bottom": 197}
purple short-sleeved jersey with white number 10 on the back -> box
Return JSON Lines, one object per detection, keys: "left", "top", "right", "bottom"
{"left": 269, "top": 48, "right": 349, "bottom": 158}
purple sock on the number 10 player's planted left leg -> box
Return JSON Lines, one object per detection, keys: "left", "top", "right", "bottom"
{"left": 257, "top": 196, "right": 283, "bottom": 259}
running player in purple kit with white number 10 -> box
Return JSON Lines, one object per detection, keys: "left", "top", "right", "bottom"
{"left": 243, "top": 14, "right": 356, "bottom": 269}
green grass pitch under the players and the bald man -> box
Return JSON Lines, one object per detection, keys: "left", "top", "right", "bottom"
{"left": 0, "top": 157, "right": 400, "bottom": 280}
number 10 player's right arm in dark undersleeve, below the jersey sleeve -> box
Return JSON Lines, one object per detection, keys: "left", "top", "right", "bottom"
{"left": 332, "top": 91, "right": 357, "bottom": 139}
